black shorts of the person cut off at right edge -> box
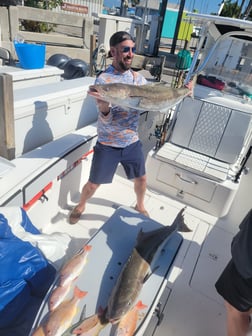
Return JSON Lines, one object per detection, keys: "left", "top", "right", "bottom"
{"left": 215, "top": 259, "right": 252, "bottom": 312}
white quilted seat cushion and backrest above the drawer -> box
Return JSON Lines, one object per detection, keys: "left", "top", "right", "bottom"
{"left": 157, "top": 98, "right": 251, "bottom": 181}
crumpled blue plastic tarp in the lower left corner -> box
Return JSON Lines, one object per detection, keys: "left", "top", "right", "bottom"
{"left": 0, "top": 209, "right": 55, "bottom": 328}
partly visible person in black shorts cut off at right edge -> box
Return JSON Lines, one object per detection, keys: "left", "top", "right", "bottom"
{"left": 215, "top": 209, "right": 252, "bottom": 336}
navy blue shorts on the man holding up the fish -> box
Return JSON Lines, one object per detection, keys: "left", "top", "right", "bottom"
{"left": 89, "top": 141, "right": 145, "bottom": 184}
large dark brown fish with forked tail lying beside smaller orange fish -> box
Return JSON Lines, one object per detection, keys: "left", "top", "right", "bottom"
{"left": 106, "top": 208, "right": 184, "bottom": 324}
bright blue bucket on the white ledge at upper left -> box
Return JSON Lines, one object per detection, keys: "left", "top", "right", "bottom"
{"left": 14, "top": 43, "right": 46, "bottom": 69}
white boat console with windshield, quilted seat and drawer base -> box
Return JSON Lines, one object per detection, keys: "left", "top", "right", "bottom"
{"left": 147, "top": 14, "right": 252, "bottom": 217}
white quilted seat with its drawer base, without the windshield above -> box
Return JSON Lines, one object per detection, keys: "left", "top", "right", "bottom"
{"left": 147, "top": 86, "right": 252, "bottom": 216}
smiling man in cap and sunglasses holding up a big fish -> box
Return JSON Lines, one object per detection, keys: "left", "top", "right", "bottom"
{"left": 69, "top": 31, "right": 148, "bottom": 224}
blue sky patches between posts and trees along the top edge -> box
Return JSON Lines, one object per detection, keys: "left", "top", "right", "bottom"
{"left": 104, "top": 0, "right": 248, "bottom": 14}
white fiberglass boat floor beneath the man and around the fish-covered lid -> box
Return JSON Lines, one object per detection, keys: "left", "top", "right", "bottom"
{"left": 23, "top": 148, "right": 251, "bottom": 336}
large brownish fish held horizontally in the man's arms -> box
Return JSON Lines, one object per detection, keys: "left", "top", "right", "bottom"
{"left": 88, "top": 83, "right": 192, "bottom": 111}
